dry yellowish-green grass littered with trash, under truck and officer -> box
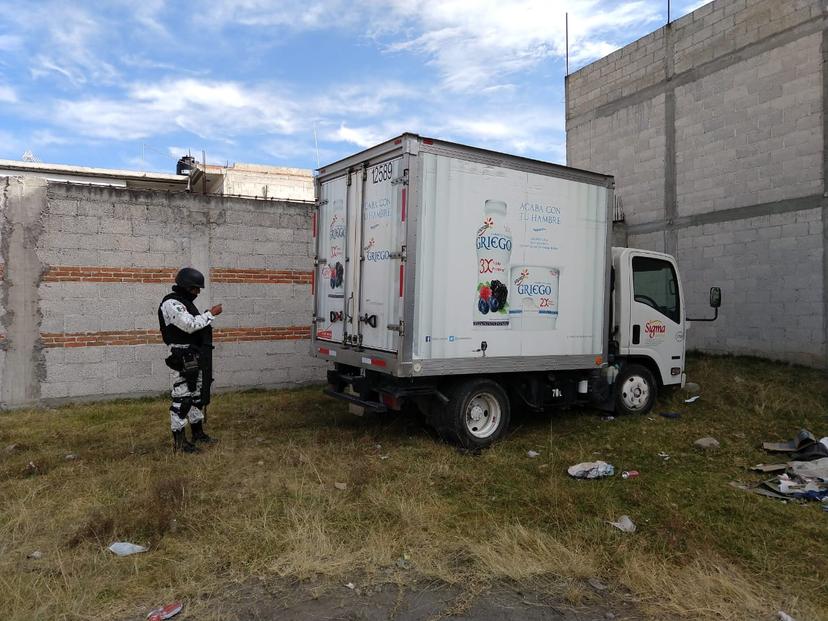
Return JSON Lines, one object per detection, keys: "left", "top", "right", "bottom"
{"left": 0, "top": 358, "right": 828, "bottom": 620}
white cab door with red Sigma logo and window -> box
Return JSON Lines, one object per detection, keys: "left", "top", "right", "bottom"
{"left": 628, "top": 254, "right": 685, "bottom": 385}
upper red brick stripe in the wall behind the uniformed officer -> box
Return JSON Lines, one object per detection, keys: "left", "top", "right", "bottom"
{"left": 38, "top": 265, "right": 311, "bottom": 285}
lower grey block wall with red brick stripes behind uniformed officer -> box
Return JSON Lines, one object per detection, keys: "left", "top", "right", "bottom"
{"left": 0, "top": 178, "right": 323, "bottom": 406}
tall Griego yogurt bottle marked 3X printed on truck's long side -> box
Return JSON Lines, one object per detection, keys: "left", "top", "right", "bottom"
{"left": 474, "top": 200, "right": 512, "bottom": 328}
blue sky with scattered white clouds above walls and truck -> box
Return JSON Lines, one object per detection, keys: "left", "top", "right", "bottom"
{"left": 0, "top": 0, "right": 705, "bottom": 172}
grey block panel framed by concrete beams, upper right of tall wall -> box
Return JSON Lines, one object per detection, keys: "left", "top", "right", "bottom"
{"left": 672, "top": 33, "right": 823, "bottom": 216}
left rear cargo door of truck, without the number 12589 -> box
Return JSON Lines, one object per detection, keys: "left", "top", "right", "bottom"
{"left": 315, "top": 176, "right": 348, "bottom": 343}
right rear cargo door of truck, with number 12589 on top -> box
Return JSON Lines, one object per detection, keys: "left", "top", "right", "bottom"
{"left": 358, "top": 157, "right": 407, "bottom": 352}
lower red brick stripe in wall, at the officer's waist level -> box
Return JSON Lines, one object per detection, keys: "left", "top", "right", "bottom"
{"left": 40, "top": 326, "right": 310, "bottom": 347}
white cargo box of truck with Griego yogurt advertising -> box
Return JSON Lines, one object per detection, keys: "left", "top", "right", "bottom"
{"left": 311, "top": 134, "right": 614, "bottom": 377}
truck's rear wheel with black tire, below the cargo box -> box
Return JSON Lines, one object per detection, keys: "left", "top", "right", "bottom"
{"left": 432, "top": 378, "right": 511, "bottom": 449}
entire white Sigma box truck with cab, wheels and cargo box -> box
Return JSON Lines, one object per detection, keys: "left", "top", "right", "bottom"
{"left": 311, "top": 134, "right": 721, "bottom": 447}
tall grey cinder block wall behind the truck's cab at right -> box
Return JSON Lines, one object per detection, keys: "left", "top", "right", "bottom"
{"left": 566, "top": 0, "right": 828, "bottom": 367}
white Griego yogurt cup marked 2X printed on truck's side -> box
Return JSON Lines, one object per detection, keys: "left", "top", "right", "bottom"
{"left": 509, "top": 265, "right": 561, "bottom": 331}
